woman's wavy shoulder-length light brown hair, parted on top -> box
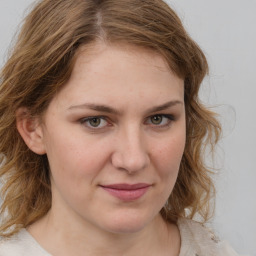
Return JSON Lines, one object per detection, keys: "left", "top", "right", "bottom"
{"left": 0, "top": 0, "right": 221, "bottom": 236}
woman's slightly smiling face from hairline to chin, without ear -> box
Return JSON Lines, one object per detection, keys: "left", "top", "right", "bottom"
{"left": 38, "top": 45, "right": 185, "bottom": 233}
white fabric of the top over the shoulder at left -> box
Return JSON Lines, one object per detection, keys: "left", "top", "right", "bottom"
{"left": 0, "top": 229, "right": 50, "bottom": 256}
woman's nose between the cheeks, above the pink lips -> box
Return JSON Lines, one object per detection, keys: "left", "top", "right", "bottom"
{"left": 112, "top": 126, "right": 150, "bottom": 174}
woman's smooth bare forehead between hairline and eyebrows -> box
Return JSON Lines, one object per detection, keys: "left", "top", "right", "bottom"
{"left": 48, "top": 44, "right": 184, "bottom": 111}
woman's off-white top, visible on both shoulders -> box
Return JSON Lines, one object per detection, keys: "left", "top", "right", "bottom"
{"left": 0, "top": 219, "right": 242, "bottom": 256}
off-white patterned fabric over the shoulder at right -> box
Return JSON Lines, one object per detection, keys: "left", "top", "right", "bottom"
{"left": 178, "top": 219, "right": 239, "bottom": 256}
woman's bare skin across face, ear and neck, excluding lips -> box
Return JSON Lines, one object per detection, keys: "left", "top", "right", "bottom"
{"left": 18, "top": 43, "right": 186, "bottom": 256}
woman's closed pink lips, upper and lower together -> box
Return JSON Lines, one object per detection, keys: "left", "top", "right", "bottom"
{"left": 101, "top": 183, "right": 151, "bottom": 201}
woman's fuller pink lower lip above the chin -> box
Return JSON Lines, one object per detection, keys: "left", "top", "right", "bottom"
{"left": 102, "top": 187, "right": 149, "bottom": 201}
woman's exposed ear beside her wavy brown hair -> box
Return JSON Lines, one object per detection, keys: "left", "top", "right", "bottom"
{"left": 16, "top": 108, "right": 46, "bottom": 155}
